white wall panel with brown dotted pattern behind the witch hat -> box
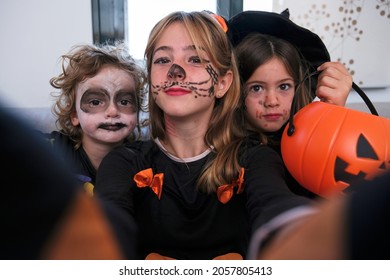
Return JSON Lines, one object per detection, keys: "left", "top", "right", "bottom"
{"left": 274, "top": 0, "right": 390, "bottom": 87}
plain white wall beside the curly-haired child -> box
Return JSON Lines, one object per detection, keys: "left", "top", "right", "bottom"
{"left": 0, "top": 0, "right": 93, "bottom": 108}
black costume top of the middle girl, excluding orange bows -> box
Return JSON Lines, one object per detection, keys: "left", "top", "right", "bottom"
{"left": 95, "top": 140, "right": 311, "bottom": 259}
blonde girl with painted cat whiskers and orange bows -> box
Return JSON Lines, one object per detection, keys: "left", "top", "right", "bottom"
{"left": 95, "top": 12, "right": 312, "bottom": 259}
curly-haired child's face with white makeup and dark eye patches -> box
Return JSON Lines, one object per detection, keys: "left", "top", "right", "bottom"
{"left": 72, "top": 66, "right": 137, "bottom": 145}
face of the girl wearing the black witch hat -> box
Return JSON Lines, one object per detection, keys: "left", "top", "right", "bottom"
{"left": 244, "top": 58, "right": 295, "bottom": 132}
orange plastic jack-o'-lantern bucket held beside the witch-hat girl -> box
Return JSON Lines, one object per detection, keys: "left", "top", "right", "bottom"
{"left": 281, "top": 102, "right": 390, "bottom": 197}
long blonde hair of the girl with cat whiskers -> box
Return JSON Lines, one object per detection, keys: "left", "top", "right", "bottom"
{"left": 145, "top": 11, "right": 243, "bottom": 193}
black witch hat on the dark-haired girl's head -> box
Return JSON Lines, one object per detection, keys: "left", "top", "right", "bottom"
{"left": 227, "top": 10, "right": 330, "bottom": 69}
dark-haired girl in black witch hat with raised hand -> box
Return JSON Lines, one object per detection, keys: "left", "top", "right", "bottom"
{"left": 228, "top": 10, "right": 352, "bottom": 198}
